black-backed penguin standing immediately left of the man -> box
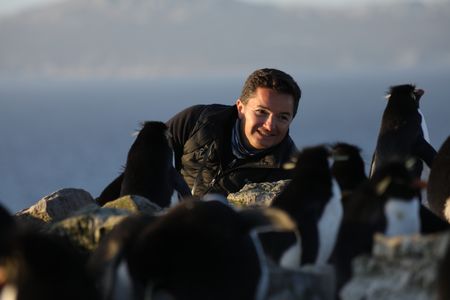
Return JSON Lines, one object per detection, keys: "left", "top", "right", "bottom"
{"left": 96, "top": 121, "right": 191, "bottom": 207}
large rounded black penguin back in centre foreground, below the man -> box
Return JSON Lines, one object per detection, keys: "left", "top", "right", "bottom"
{"left": 125, "top": 200, "right": 260, "bottom": 300}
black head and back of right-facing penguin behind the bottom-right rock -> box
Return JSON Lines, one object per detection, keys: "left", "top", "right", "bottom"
{"left": 331, "top": 161, "right": 418, "bottom": 290}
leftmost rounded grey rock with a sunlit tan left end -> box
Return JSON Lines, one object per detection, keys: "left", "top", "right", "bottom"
{"left": 15, "top": 188, "right": 95, "bottom": 225}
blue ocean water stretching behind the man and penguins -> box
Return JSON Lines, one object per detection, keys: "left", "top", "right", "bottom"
{"left": 0, "top": 71, "right": 450, "bottom": 212}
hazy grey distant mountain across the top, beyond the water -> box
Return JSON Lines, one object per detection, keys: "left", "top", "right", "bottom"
{"left": 0, "top": 0, "right": 450, "bottom": 77}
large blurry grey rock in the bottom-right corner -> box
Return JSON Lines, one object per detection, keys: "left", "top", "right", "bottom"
{"left": 340, "top": 232, "right": 450, "bottom": 300}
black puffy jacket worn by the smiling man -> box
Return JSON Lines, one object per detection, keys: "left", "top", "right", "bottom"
{"left": 167, "top": 104, "right": 297, "bottom": 195}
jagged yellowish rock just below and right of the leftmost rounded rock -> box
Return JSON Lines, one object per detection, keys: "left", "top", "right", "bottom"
{"left": 47, "top": 206, "right": 132, "bottom": 253}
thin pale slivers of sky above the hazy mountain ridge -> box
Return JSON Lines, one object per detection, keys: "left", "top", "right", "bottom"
{"left": 0, "top": 0, "right": 422, "bottom": 13}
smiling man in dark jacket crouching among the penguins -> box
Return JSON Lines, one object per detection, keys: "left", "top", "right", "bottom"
{"left": 167, "top": 69, "right": 301, "bottom": 196}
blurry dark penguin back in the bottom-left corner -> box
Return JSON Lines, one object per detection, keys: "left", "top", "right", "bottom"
{"left": 2, "top": 229, "right": 99, "bottom": 300}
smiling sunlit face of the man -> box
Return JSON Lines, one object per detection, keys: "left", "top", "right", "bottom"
{"left": 236, "top": 87, "right": 294, "bottom": 149}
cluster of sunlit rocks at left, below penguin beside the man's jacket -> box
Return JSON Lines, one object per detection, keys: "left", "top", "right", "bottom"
{"left": 15, "top": 188, "right": 162, "bottom": 253}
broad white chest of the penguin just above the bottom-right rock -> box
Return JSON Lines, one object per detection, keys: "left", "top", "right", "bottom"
{"left": 384, "top": 198, "right": 420, "bottom": 236}
